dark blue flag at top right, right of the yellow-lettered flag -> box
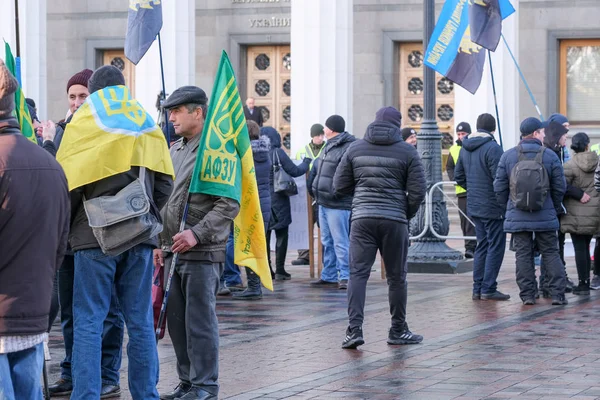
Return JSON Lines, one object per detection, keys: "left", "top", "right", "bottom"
{"left": 469, "top": 0, "right": 515, "bottom": 51}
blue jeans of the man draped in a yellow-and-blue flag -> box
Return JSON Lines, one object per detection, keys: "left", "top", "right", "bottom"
{"left": 71, "top": 245, "right": 158, "bottom": 400}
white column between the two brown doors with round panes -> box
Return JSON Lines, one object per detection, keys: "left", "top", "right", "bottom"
{"left": 291, "top": 0, "right": 354, "bottom": 154}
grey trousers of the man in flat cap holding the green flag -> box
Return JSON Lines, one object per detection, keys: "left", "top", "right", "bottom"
{"left": 165, "top": 257, "right": 223, "bottom": 396}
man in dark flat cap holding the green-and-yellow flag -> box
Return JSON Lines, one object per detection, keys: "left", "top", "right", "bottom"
{"left": 154, "top": 86, "right": 240, "bottom": 400}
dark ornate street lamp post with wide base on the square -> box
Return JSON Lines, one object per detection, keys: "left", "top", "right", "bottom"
{"left": 408, "top": 0, "right": 472, "bottom": 273}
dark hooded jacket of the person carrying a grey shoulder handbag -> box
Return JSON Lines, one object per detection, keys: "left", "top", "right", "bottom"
{"left": 260, "top": 126, "right": 312, "bottom": 230}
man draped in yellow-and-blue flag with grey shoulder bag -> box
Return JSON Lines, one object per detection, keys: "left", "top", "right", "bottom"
{"left": 57, "top": 66, "right": 174, "bottom": 400}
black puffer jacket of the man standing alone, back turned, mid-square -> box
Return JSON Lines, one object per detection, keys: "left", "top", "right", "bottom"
{"left": 333, "top": 121, "right": 427, "bottom": 223}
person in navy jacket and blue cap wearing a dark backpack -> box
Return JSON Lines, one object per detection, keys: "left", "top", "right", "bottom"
{"left": 494, "top": 118, "right": 568, "bottom": 305}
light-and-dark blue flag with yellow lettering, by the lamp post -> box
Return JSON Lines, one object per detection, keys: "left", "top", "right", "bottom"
{"left": 425, "top": 0, "right": 485, "bottom": 93}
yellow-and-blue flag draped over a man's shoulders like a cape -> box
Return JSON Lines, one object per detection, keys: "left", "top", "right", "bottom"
{"left": 56, "top": 86, "right": 175, "bottom": 190}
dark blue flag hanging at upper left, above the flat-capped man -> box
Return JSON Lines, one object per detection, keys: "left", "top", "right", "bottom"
{"left": 125, "top": 0, "right": 162, "bottom": 65}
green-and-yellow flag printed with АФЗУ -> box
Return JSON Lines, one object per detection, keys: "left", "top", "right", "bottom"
{"left": 190, "top": 52, "right": 273, "bottom": 290}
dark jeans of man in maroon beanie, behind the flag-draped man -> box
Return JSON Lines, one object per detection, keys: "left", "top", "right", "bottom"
{"left": 58, "top": 255, "right": 125, "bottom": 385}
